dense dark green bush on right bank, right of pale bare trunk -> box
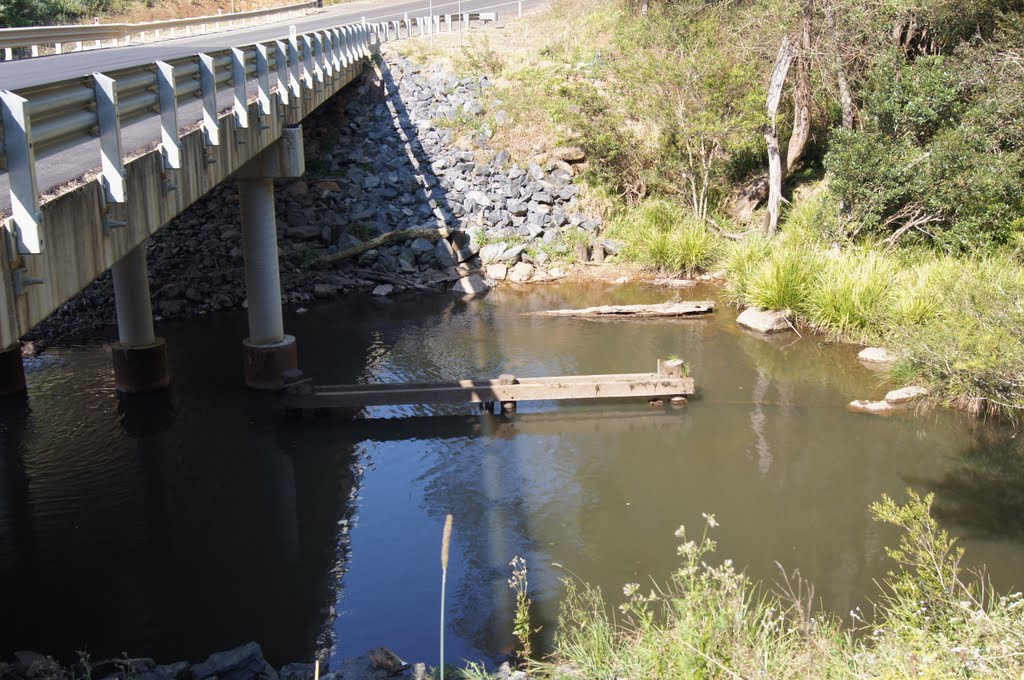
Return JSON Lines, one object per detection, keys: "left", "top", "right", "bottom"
{"left": 824, "top": 45, "right": 1024, "bottom": 253}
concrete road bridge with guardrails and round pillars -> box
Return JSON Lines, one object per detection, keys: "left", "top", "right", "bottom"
{"left": 0, "top": 0, "right": 522, "bottom": 395}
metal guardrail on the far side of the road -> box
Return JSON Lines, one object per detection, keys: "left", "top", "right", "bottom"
{"left": 0, "top": 0, "right": 321, "bottom": 61}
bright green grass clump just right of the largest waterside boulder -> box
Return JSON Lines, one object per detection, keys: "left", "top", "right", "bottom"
{"left": 804, "top": 250, "right": 898, "bottom": 341}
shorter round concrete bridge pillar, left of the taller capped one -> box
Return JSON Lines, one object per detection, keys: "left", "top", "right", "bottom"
{"left": 111, "top": 244, "right": 171, "bottom": 392}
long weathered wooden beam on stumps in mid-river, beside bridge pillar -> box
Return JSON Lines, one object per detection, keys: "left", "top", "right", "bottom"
{"left": 283, "top": 359, "right": 694, "bottom": 410}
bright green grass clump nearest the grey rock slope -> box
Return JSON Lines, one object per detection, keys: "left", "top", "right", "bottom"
{"left": 611, "top": 200, "right": 719, "bottom": 275}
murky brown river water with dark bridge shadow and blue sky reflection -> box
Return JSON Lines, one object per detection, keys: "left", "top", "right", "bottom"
{"left": 0, "top": 286, "right": 1024, "bottom": 664}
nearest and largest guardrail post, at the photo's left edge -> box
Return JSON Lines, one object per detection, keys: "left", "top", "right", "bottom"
{"left": 0, "top": 90, "right": 43, "bottom": 253}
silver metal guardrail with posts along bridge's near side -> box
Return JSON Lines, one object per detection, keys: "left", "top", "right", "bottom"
{"left": 0, "top": 12, "right": 498, "bottom": 254}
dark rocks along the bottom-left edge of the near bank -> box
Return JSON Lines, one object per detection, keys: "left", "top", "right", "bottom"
{"left": 0, "top": 642, "right": 527, "bottom": 680}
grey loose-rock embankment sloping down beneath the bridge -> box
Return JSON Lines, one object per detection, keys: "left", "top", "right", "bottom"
{"left": 28, "top": 49, "right": 616, "bottom": 343}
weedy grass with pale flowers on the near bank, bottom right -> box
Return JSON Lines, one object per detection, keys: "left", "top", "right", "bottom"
{"left": 537, "top": 492, "right": 1024, "bottom": 680}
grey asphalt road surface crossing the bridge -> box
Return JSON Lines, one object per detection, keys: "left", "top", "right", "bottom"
{"left": 0, "top": 0, "right": 544, "bottom": 215}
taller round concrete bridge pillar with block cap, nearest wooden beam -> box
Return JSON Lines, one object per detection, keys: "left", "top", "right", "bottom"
{"left": 238, "top": 127, "right": 305, "bottom": 389}
